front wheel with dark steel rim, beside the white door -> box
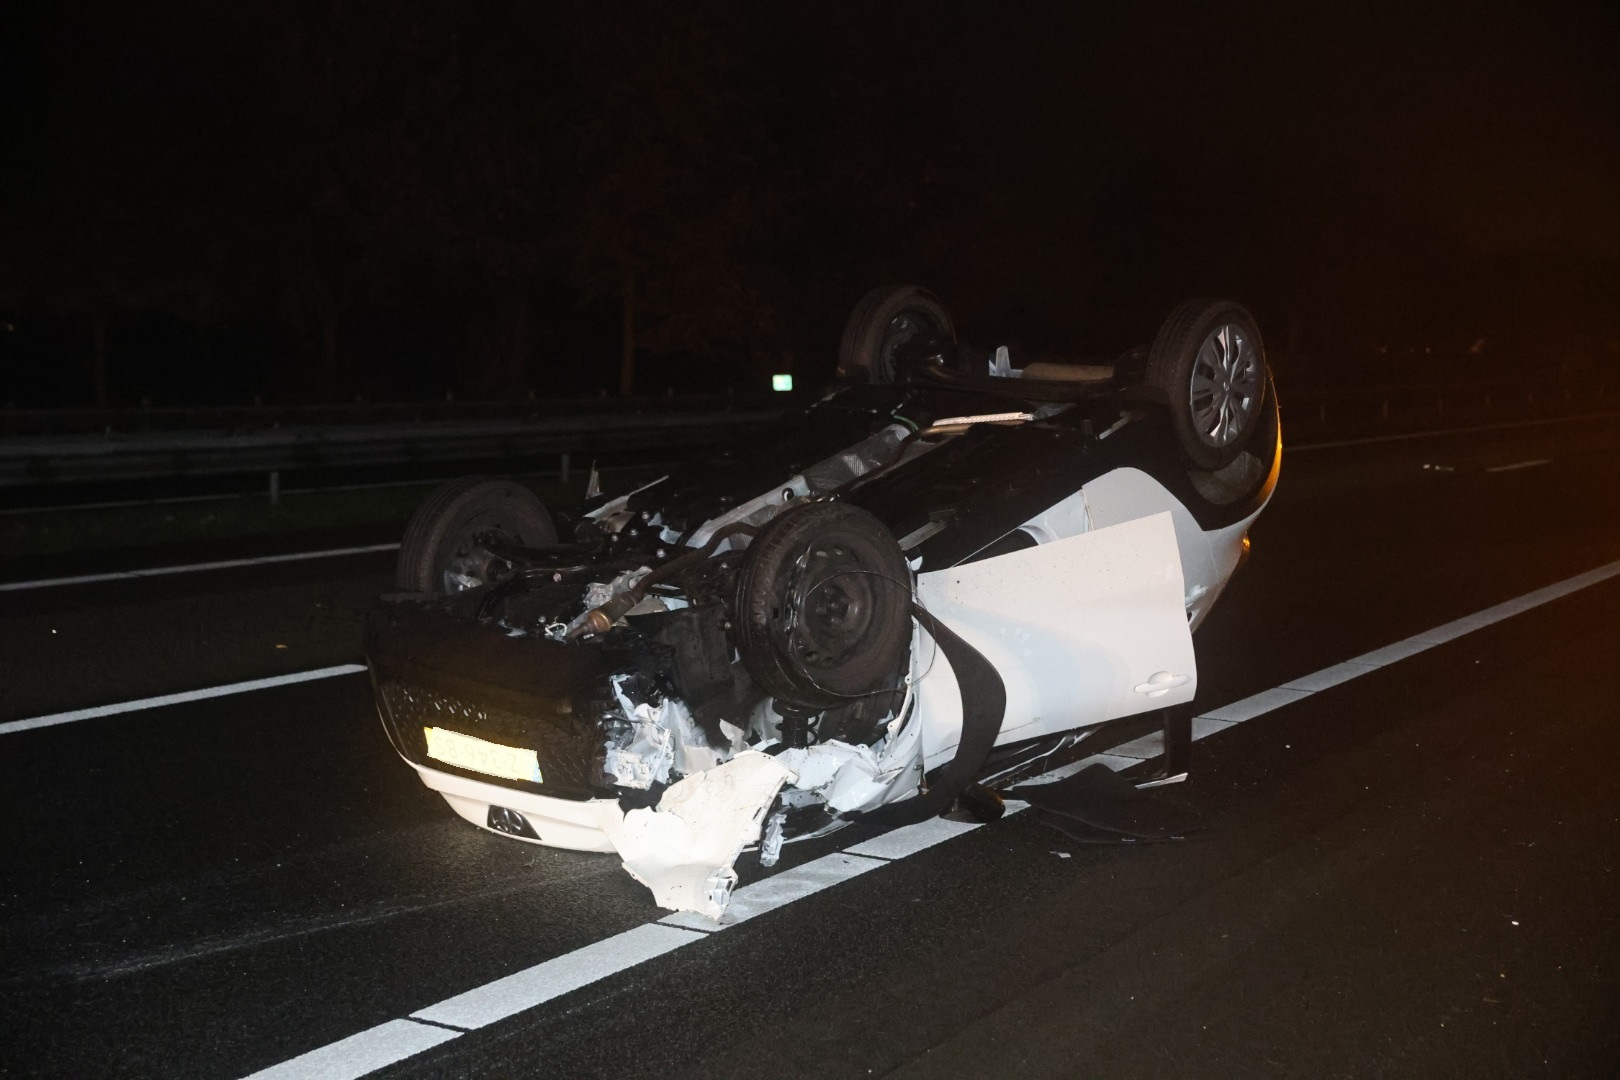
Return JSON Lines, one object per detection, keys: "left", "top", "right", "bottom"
{"left": 735, "top": 502, "right": 912, "bottom": 709}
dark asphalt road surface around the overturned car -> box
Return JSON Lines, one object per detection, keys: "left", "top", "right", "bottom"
{"left": 0, "top": 421, "right": 1620, "bottom": 1080}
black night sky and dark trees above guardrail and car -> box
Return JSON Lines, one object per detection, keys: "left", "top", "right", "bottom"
{"left": 0, "top": 0, "right": 1620, "bottom": 403}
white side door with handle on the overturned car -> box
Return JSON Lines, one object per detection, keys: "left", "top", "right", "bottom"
{"left": 914, "top": 512, "right": 1202, "bottom": 769}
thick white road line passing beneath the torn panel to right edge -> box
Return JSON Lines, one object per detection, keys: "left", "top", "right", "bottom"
{"left": 249, "top": 560, "right": 1620, "bottom": 1080}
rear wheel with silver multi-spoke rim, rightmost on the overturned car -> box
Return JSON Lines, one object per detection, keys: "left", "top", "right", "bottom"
{"left": 1145, "top": 300, "right": 1268, "bottom": 470}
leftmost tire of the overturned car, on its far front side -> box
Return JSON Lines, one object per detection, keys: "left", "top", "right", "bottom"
{"left": 395, "top": 476, "right": 557, "bottom": 596}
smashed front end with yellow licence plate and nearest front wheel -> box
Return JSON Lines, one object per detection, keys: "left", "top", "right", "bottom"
{"left": 366, "top": 429, "right": 922, "bottom": 918}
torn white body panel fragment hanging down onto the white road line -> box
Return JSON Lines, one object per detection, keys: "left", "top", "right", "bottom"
{"left": 609, "top": 750, "right": 794, "bottom": 921}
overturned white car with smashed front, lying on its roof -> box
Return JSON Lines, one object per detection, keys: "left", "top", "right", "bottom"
{"left": 368, "top": 287, "right": 1281, "bottom": 918}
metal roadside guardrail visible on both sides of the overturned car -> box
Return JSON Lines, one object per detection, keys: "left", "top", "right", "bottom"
{"left": 0, "top": 379, "right": 1620, "bottom": 499}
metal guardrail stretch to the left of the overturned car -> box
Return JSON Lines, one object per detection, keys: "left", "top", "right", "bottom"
{"left": 0, "top": 410, "right": 781, "bottom": 491}
